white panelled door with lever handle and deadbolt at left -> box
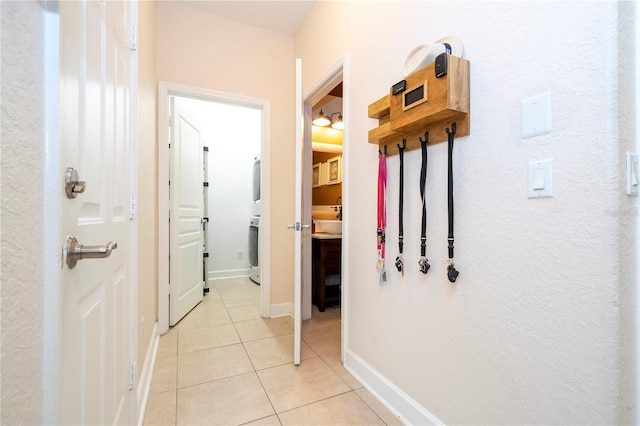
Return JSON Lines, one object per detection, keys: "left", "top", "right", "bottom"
{"left": 57, "top": 1, "right": 136, "bottom": 424}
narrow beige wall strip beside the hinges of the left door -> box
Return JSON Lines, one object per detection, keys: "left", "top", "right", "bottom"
{"left": 137, "top": 1, "right": 158, "bottom": 386}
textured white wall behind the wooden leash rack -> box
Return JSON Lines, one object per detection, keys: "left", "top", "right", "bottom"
{"left": 294, "top": 1, "right": 637, "bottom": 424}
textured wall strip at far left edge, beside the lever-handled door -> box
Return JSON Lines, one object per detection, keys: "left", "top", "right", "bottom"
{"left": 0, "top": 2, "right": 45, "bottom": 424}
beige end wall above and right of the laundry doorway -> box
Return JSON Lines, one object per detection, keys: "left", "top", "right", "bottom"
{"left": 156, "top": 2, "right": 295, "bottom": 304}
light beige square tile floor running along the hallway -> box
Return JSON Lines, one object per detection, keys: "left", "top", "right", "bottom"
{"left": 144, "top": 278, "right": 401, "bottom": 425}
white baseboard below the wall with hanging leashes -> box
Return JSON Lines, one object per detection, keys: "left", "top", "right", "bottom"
{"left": 344, "top": 349, "right": 444, "bottom": 425}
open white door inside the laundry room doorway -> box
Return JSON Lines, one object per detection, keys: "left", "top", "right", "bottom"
{"left": 169, "top": 97, "right": 204, "bottom": 326}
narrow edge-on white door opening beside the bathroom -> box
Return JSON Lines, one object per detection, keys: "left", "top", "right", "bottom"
{"left": 289, "top": 58, "right": 309, "bottom": 365}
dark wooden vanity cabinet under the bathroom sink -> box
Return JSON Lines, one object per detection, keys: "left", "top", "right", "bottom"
{"left": 311, "top": 236, "right": 342, "bottom": 312}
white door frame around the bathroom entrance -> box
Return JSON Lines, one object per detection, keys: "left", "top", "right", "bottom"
{"left": 302, "top": 52, "right": 350, "bottom": 360}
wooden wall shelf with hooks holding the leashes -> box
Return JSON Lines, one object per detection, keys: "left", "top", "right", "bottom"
{"left": 368, "top": 55, "right": 470, "bottom": 155}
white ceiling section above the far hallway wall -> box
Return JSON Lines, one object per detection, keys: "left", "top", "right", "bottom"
{"left": 176, "top": 0, "right": 315, "bottom": 35}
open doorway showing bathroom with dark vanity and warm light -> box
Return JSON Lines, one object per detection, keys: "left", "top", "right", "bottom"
{"left": 302, "top": 55, "right": 348, "bottom": 359}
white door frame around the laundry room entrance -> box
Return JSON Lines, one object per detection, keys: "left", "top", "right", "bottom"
{"left": 158, "top": 81, "right": 271, "bottom": 334}
